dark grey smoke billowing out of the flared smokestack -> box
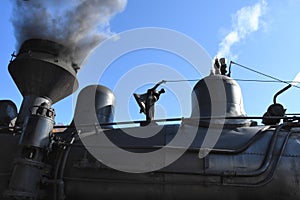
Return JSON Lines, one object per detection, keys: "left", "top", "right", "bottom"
{"left": 12, "top": 0, "right": 127, "bottom": 65}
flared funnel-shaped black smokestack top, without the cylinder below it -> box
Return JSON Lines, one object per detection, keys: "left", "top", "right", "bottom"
{"left": 8, "top": 39, "right": 78, "bottom": 126}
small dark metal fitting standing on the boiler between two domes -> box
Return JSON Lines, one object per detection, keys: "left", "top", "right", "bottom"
{"left": 133, "top": 81, "right": 165, "bottom": 125}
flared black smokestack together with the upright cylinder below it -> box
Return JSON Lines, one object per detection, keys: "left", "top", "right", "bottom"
{"left": 5, "top": 39, "right": 78, "bottom": 199}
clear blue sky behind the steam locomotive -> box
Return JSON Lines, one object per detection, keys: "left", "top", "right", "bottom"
{"left": 0, "top": 0, "right": 300, "bottom": 124}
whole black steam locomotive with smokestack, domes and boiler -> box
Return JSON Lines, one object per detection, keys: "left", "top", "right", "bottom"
{"left": 0, "top": 39, "right": 300, "bottom": 200}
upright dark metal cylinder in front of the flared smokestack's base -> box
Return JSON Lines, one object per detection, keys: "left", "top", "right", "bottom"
{"left": 5, "top": 103, "right": 55, "bottom": 199}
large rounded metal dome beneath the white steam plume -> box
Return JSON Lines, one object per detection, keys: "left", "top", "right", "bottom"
{"left": 191, "top": 75, "right": 249, "bottom": 125}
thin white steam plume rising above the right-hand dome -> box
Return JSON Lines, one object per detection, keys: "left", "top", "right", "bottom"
{"left": 216, "top": 0, "right": 267, "bottom": 58}
